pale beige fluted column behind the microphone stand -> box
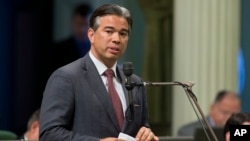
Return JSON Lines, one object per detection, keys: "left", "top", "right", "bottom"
{"left": 172, "top": 0, "right": 240, "bottom": 135}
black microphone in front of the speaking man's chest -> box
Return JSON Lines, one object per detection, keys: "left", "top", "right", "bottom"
{"left": 123, "top": 62, "right": 134, "bottom": 121}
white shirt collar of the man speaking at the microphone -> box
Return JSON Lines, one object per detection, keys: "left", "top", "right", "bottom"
{"left": 89, "top": 51, "right": 117, "bottom": 78}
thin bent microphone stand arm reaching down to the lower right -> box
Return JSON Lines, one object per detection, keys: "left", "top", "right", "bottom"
{"left": 134, "top": 81, "right": 218, "bottom": 141}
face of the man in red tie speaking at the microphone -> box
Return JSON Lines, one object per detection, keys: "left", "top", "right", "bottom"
{"left": 88, "top": 15, "right": 129, "bottom": 67}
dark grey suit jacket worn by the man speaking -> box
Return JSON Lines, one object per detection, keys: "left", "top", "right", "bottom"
{"left": 40, "top": 55, "right": 149, "bottom": 141}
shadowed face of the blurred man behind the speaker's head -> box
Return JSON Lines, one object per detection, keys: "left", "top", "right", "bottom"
{"left": 72, "top": 14, "right": 89, "bottom": 40}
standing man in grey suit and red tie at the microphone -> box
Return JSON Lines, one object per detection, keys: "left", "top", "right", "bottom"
{"left": 40, "top": 4, "right": 159, "bottom": 141}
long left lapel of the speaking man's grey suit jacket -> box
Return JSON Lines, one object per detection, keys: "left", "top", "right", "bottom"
{"left": 82, "top": 54, "right": 119, "bottom": 130}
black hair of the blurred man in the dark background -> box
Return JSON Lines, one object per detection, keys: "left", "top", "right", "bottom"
{"left": 73, "top": 3, "right": 92, "bottom": 17}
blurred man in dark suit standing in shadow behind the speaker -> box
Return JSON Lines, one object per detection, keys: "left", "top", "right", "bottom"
{"left": 50, "top": 3, "right": 92, "bottom": 71}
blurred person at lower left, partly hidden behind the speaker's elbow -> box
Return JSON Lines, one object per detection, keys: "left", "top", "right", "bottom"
{"left": 20, "top": 109, "right": 40, "bottom": 141}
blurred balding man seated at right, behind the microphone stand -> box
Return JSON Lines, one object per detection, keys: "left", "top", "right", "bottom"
{"left": 178, "top": 90, "right": 241, "bottom": 136}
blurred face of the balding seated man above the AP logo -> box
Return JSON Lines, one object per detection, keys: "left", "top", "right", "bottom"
{"left": 210, "top": 95, "right": 240, "bottom": 126}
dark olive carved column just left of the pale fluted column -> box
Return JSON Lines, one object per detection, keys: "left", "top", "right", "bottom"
{"left": 138, "top": 0, "right": 173, "bottom": 134}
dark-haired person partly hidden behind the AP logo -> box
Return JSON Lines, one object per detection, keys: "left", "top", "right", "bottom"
{"left": 223, "top": 113, "right": 250, "bottom": 141}
